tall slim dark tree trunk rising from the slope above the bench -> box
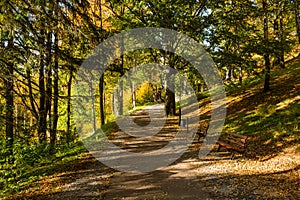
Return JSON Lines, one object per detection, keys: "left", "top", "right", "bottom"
{"left": 262, "top": 0, "right": 271, "bottom": 92}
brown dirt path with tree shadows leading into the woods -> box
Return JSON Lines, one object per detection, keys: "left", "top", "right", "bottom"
{"left": 104, "top": 106, "right": 213, "bottom": 199}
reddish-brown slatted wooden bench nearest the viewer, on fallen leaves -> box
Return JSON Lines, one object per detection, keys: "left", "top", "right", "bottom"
{"left": 217, "top": 133, "right": 249, "bottom": 159}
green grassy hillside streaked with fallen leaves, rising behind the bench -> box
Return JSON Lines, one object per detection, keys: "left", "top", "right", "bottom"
{"left": 200, "top": 59, "right": 300, "bottom": 158}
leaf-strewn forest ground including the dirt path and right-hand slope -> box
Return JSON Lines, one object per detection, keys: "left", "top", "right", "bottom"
{"left": 7, "top": 59, "right": 300, "bottom": 199}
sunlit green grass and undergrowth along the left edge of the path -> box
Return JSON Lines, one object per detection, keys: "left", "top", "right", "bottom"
{"left": 0, "top": 142, "right": 87, "bottom": 198}
